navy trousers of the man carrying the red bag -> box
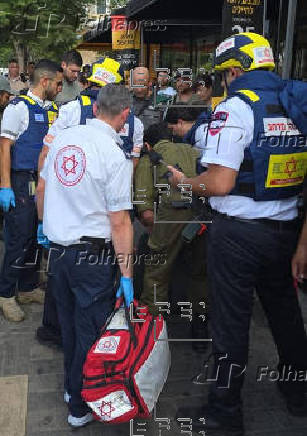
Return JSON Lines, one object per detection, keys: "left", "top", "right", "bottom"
{"left": 49, "top": 244, "right": 117, "bottom": 417}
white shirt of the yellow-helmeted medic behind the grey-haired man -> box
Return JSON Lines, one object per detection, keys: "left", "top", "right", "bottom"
{"left": 44, "top": 100, "right": 144, "bottom": 149}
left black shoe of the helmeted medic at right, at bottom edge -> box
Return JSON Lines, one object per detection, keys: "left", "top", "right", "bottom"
{"left": 176, "top": 406, "right": 244, "bottom": 436}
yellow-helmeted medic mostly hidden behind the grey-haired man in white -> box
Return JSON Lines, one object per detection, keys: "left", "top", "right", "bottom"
{"left": 36, "top": 57, "right": 144, "bottom": 345}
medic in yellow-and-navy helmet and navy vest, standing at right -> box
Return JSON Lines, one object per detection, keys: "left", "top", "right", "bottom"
{"left": 170, "top": 33, "right": 307, "bottom": 436}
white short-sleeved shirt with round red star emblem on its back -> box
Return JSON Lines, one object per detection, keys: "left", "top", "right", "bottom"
{"left": 41, "top": 119, "right": 133, "bottom": 246}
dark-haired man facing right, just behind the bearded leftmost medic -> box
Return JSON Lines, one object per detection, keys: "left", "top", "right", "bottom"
{"left": 56, "top": 50, "right": 83, "bottom": 106}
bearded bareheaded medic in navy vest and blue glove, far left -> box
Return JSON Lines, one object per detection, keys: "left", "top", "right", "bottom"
{"left": 0, "top": 59, "right": 63, "bottom": 322}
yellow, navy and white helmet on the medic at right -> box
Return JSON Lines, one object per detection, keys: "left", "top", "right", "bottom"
{"left": 214, "top": 32, "right": 275, "bottom": 71}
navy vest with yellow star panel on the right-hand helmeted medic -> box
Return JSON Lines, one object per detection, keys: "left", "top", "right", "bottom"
{"left": 220, "top": 71, "right": 307, "bottom": 201}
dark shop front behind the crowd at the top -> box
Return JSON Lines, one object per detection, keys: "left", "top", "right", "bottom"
{"left": 79, "top": 0, "right": 307, "bottom": 80}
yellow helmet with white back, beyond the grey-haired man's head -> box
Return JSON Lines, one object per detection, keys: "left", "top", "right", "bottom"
{"left": 87, "top": 57, "right": 122, "bottom": 86}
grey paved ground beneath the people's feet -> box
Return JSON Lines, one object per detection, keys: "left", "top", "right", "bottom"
{"left": 0, "top": 238, "right": 307, "bottom": 436}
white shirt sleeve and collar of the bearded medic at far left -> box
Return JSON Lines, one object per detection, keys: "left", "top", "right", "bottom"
{"left": 1, "top": 90, "right": 52, "bottom": 141}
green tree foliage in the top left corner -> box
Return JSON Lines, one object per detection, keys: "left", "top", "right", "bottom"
{"left": 0, "top": 0, "right": 94, "bottom": 67}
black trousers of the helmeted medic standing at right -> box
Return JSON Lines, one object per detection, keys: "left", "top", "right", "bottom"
{"left": 207, "top": 216, "right": 307, "bottom": 417}
